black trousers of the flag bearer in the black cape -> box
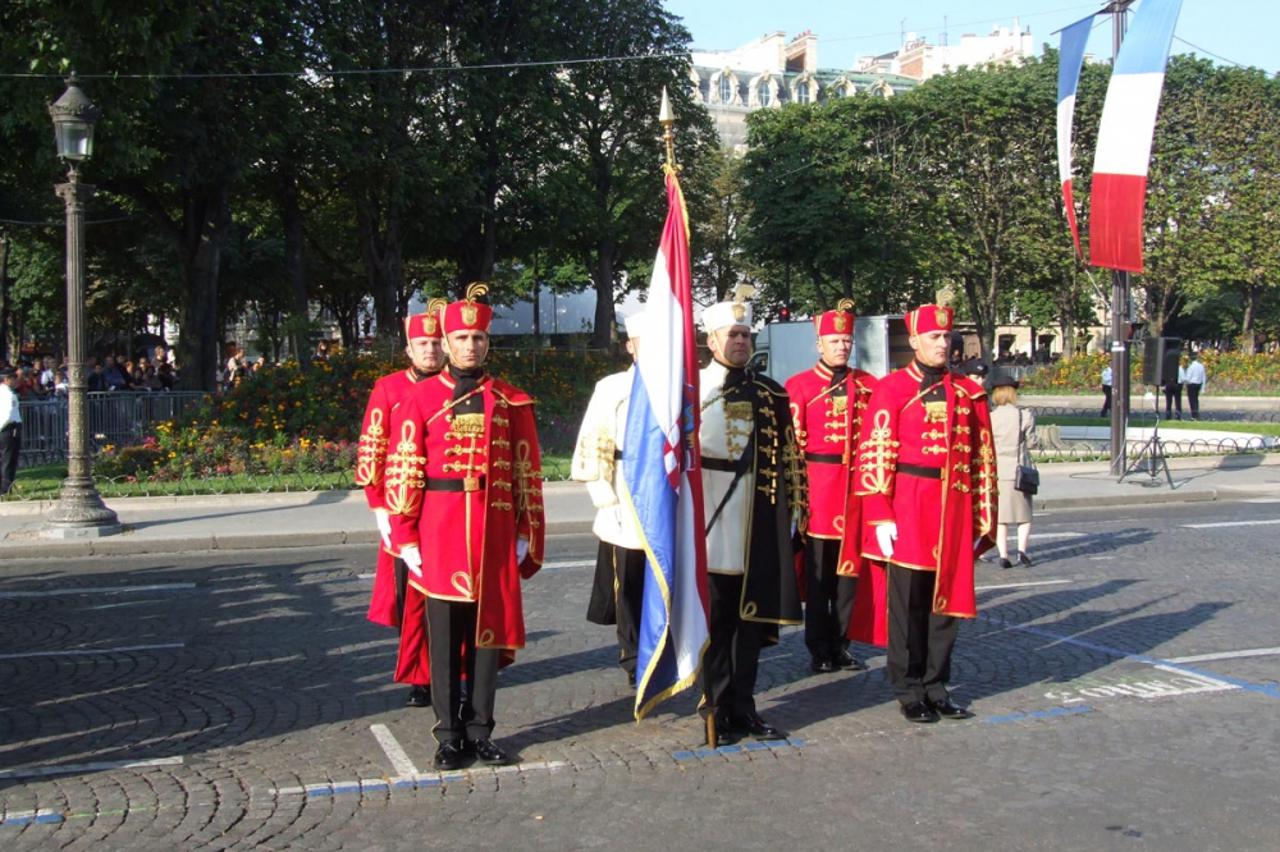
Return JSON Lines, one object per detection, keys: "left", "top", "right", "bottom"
{"left": 703, "top": 574, "right": 765, "bottom": 719}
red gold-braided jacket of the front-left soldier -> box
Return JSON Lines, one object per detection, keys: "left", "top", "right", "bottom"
{"left": 385, "top": 371, "right": 545, "bottom": 650}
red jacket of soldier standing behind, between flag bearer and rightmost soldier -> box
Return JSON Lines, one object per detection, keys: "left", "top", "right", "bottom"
{"left": 786, "top": 361, "right": 876, "bottom": 577}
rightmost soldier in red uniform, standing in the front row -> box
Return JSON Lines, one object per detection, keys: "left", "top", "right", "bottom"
{"left": 846, "top": 304, "right": 996, "bottom": 723}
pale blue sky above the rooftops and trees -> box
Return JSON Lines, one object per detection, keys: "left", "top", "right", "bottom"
{"left": 664, "top": 0, "right": 1280, "bottom": 73}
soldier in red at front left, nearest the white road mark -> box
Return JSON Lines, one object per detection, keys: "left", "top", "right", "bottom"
{"left": 387, "top": 284, "right": 545, "bottom": 770}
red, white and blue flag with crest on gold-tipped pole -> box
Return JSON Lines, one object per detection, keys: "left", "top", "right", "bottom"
{"left": 622, "top": 169, "right": 709, "bottom": 719}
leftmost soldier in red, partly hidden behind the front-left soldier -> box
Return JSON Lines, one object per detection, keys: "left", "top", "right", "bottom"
{"left": 356, "top": 299, "right": 445, "bottom": 707}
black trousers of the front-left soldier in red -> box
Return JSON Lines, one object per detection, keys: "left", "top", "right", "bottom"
{"left": 426, "top": 597, "right": 500, "bottom": 742}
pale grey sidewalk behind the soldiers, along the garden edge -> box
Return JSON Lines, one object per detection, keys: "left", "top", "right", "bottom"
{"left": 0, "top": 453, "right": 1280, "bottom": 564}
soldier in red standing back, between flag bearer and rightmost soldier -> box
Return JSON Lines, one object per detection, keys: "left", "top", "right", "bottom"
{"left": 786, "top": 299, "right": 876, "bottom": 673}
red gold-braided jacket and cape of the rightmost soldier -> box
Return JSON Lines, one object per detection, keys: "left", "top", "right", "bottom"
{"left": 846, "top": 362, "right": 997, "bottom": 643}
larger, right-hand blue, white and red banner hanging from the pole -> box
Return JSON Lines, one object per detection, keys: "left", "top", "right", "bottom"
{"left": 1089, "top": 0, "right": 1181, "bottom": 272}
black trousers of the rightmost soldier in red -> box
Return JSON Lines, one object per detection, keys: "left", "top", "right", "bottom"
{"left": 884, "top": 564, "right": 960, "bottom": 705}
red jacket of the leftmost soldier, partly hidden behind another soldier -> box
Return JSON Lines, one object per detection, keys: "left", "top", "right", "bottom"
{"left": 356, "top": 370, "right": 419, "bottom": 627}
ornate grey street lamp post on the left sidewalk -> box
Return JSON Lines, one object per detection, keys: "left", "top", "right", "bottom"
{"left": 41, "top": 72, "right": 120, "bottom": 539}
